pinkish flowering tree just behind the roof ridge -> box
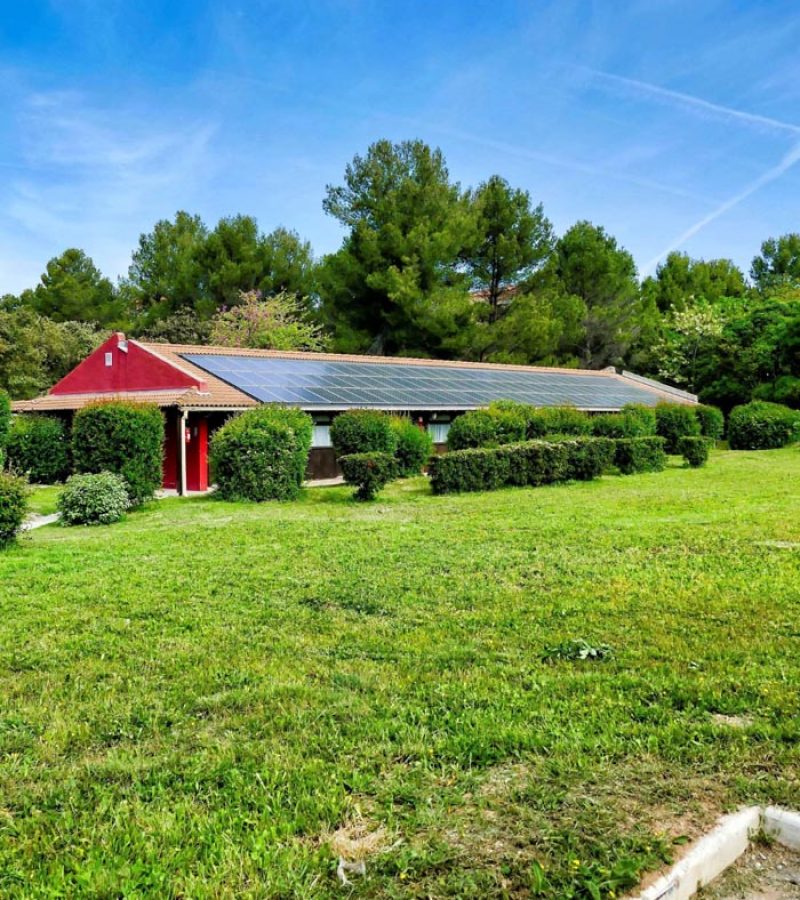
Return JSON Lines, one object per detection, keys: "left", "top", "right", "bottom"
{"left": 211, "top": 291, "right": 328, "bottom": 351}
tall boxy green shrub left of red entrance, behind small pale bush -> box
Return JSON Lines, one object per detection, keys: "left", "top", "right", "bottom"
{"left": 72, "top": 400, "right": 164, "bottom": 505}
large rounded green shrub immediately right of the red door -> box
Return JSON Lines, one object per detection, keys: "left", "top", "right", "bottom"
{"left": 210, "top": 406, "right": 313, "bottom": 502}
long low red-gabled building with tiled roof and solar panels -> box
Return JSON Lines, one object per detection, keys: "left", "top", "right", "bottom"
{"left": 14, "top": 333, "right": 697, "bottom": 493}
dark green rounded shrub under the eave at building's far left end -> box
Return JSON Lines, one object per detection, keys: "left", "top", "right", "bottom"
{"left": 6, "top": 415, "right": 69, "bottom": 484}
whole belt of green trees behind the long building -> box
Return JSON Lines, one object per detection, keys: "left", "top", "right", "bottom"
{"left": 0, "top": 141, "right": 800, "bottom": 409}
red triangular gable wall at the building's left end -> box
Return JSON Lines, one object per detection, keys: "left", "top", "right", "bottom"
{"left": 50, "top": 333, "right": 206, "bottom": 394}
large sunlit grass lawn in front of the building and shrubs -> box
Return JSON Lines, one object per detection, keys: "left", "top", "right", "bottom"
{"left": 0, "top": 448, "right": 800, "bottom": 898}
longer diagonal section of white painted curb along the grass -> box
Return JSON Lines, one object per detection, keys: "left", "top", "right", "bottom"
{"left": 639, "top": 806, "right": 761, "bottom": 900}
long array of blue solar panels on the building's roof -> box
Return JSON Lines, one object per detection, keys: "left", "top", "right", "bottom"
{"left": 183, "top": 353, "right": 658, "bottom": 411}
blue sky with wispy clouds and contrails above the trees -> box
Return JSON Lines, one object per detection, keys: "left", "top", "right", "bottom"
{"left": 0, "top": 0, "right": 800, "bottom": 294}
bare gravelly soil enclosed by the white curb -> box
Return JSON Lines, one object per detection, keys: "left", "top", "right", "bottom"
{"left": 698, "top": 844, "right": 800, "bottom": 900}
